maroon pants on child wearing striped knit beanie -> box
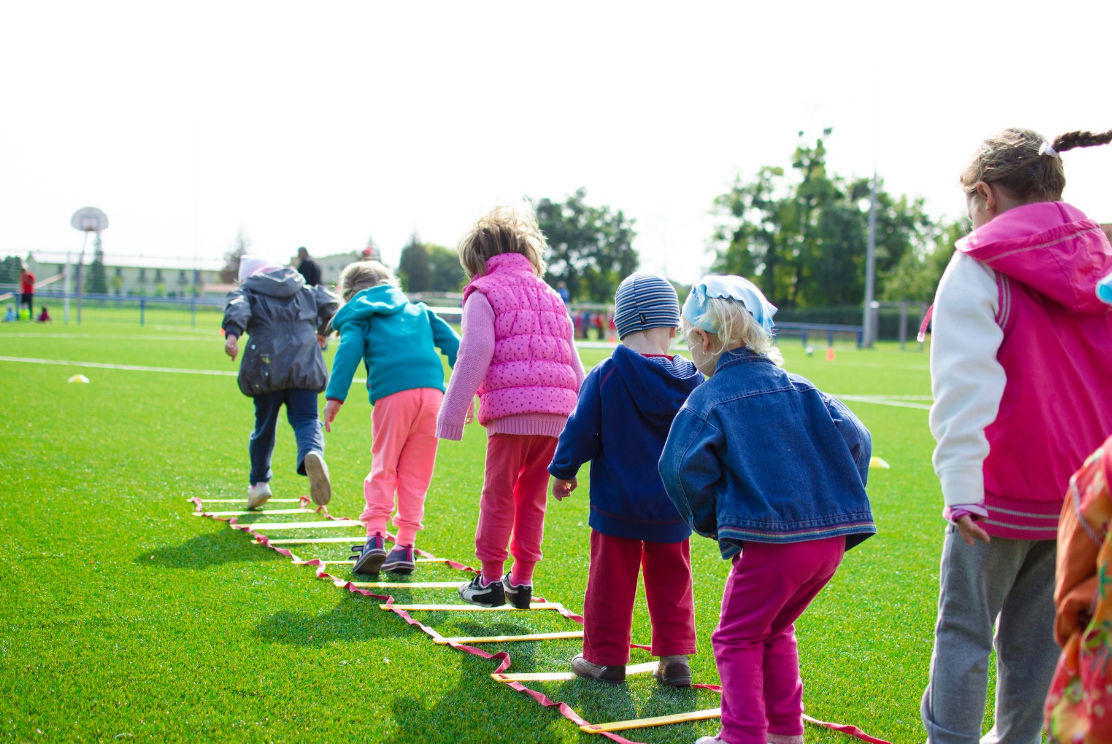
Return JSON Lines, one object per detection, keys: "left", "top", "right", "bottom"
{"left": 583, "top": 530, "right": 695, "bottom": 666}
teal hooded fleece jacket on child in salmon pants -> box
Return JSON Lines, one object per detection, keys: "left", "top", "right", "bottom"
{"left": 325, "top": 285, "right": 459, "bottom": 404}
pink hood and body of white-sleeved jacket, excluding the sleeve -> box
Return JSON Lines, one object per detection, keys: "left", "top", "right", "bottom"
{"left": 956, "top": 201, "right": 1112, "bottom": 539}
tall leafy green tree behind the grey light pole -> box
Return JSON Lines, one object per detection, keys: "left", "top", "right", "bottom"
{"left": 713, "top": 129, "right": 937, "bottom": 307}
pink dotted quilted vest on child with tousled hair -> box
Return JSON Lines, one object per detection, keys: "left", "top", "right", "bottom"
{"left": 464, "top": 254, "right": 579, "bottom": 426}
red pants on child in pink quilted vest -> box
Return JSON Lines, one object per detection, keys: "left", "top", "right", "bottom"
{"left": 475, "top": 434, "right": 556, "bottom": 584}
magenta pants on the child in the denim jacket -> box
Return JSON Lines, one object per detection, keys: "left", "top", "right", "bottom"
{"left": 711, "top": 537, "right": 845, "bottom": 744}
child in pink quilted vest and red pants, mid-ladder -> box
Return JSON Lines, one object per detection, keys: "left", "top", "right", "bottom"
{"left": 436, "top": 208, "right": 584, "bottom": 609}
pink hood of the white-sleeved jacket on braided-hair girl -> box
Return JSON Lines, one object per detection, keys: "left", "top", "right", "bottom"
{"left": 956, "top": 201, "right": 1112, "bottom": 315}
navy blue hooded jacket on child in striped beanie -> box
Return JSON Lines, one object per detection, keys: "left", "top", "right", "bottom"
{"left": 548, "top": 345, "right": 704, "bottom": 543}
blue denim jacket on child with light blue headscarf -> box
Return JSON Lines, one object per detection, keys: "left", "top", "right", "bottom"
{"left": 659, "top": 348, "right": 876, "bottom": 558}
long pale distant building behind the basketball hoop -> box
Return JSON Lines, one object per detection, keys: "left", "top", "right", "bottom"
{"left": 27, "top": 250, "right": 228, "bottom": 297}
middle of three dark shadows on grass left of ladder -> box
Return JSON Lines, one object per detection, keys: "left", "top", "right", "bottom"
{"left": 251, "top": 593, "right": 417, "bottom": 647}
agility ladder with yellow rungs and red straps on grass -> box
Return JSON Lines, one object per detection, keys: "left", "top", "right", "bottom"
{"left": 189, "top": 496, "right": 888, "bottom": 744}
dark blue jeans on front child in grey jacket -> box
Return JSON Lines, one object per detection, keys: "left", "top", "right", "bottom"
{"left": 248, "top": 390, "right": 325, "bottom": 486}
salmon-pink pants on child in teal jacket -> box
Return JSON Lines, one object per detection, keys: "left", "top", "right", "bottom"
{"left": 359, "top": 387, "right": 444, "bottom": 545}
